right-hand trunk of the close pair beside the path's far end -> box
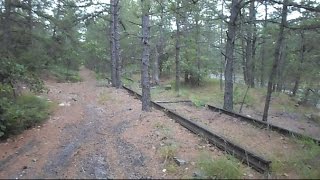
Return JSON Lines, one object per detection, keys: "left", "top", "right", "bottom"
{"left": 113, "top": 0, "right": 122, "bottom": 88}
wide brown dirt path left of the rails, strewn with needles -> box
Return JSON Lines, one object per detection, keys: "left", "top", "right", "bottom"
{"left": 0, "top": 69, "right": 262, "bottom": 179}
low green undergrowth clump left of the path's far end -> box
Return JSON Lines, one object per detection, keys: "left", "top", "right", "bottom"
{"left": 50, "top": 66, "right": 82, "bottom": 82}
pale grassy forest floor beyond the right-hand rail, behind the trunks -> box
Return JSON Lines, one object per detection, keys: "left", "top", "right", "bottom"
{"left": 125, "top": 74, "right": 320, "bottom": 140}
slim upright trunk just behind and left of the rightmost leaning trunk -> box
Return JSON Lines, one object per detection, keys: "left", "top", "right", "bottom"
{"left": 260, "top": 0, "right": 268, "bottom": 87}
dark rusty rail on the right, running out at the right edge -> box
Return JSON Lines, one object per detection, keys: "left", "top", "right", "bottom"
{"left": 206, "top": 104, "right": 320, "bottom": 145}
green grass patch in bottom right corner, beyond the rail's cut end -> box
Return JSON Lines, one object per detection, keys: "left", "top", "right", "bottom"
{"left": 272, "top": 138, "right": 320, "bottom": 179}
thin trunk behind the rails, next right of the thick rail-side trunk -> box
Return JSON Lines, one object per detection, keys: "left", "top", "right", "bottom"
{"left": 175, "top": 0, "right": 180, "bottom": 92}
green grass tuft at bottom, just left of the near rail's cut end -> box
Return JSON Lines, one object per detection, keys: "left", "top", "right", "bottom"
{"left": 197, "top": 152, "right": 244, "bottom": 179}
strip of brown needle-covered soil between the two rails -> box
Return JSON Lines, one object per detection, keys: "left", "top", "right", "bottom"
{"left": 163, "top": 103, "right": 319, "bottom": 178}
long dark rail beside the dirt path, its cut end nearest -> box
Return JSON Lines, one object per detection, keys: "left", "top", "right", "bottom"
{"left": 123, "top": 86, "right": 271, "bottom": 173}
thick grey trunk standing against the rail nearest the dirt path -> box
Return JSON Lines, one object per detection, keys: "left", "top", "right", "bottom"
{"left": 141, "top": 0, "right": 151, "bottom": 111}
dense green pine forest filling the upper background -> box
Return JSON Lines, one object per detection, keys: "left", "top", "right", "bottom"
{"left": 0, "top": 0, "right": 320, "bottom": 136}
